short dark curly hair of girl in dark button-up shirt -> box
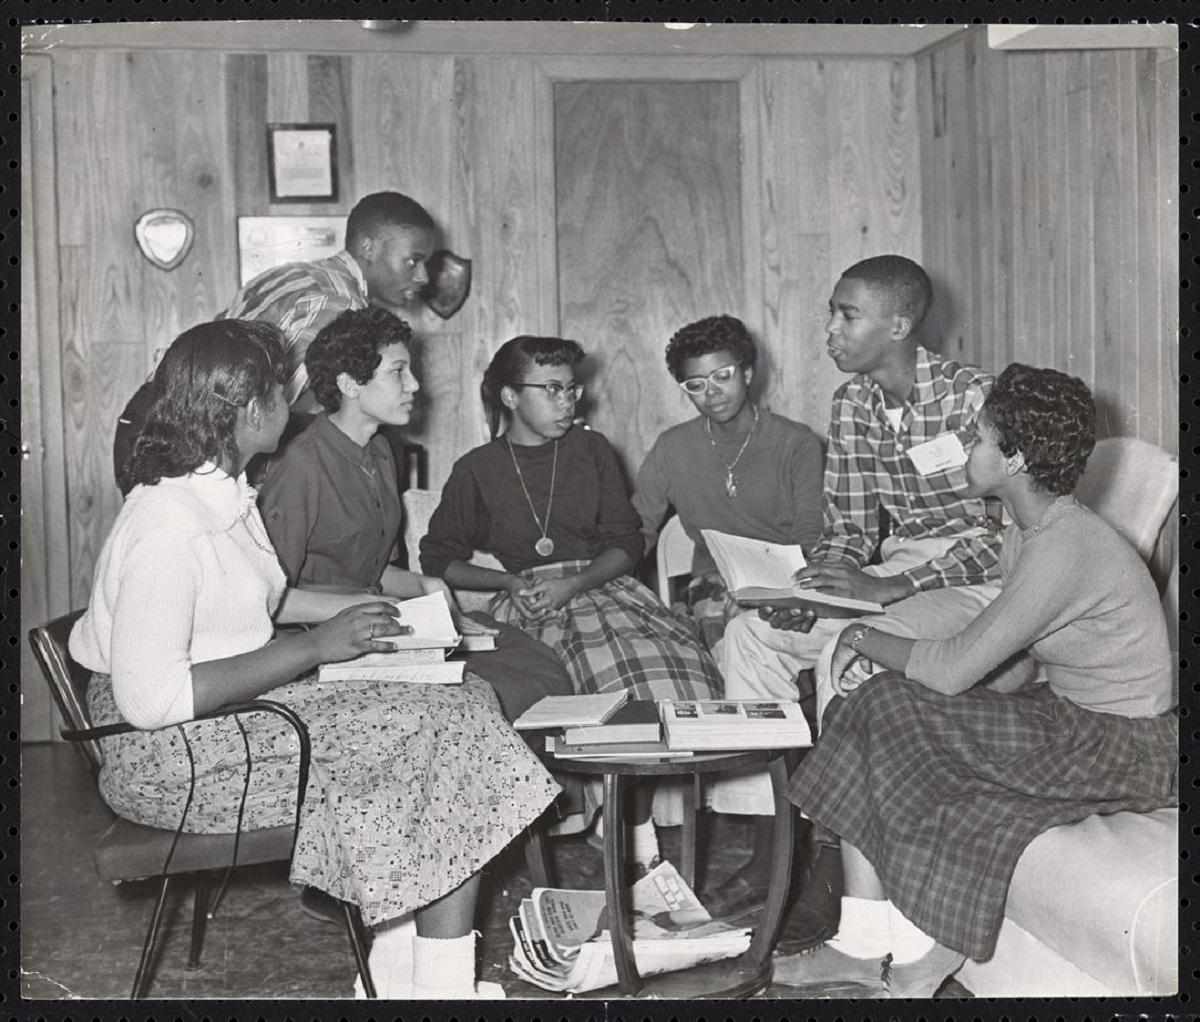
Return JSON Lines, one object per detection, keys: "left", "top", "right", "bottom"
{"left": 304, "top": 306, "right": 413, "bottom": 411}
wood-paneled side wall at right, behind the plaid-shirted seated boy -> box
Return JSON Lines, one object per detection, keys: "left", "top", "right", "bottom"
{"left": 916, "top": 29, "right": 1178, "bottom": 451}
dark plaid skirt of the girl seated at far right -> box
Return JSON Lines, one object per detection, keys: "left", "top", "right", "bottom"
{"left": 787, "top": 672, "right": 1178, "bottom": 961}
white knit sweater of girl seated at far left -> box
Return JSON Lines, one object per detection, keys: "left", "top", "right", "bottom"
{"left": 70, "top": 464, "right": 286, "bottom": 728}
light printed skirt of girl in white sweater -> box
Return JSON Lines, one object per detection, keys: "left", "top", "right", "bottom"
{"left": 89, "top": 674, "right": 558, "bottom": 925}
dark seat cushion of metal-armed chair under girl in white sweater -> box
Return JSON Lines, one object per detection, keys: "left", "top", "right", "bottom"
{"left": 92, "top": 819, "right": 294, "bottom": 880}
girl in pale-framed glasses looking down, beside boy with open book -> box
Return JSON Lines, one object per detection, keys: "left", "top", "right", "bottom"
{"left": 634, "top": 315, "right": 824, "bottom": 649}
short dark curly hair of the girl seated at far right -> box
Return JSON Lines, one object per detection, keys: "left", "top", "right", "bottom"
{"left": 980, "top": 362, "right": 1096, "bottom": 495}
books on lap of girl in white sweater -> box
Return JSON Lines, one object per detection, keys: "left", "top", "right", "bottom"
{"left": 317, "top": 593, "right": 496, "bottom": 685}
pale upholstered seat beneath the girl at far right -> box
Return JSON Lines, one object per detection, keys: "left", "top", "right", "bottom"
{"left": 965, "top": 808, "right": 1178, "bottom": 994}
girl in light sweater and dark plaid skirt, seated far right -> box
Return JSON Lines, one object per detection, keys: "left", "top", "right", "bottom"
{"left": 775, "top": 363, "right": 1178, "bottom": 997}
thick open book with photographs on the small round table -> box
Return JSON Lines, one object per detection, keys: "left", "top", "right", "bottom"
{"left": 659, "top": 699, "right": 812, "bottom": 752}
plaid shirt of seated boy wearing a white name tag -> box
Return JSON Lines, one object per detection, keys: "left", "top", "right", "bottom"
{"left": 815, "top": 347, "right": 1001, "bottom": 591}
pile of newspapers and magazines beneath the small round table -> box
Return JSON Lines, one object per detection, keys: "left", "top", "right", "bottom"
{"left": 509, "top": 862, "right": 751, "bottom": 993}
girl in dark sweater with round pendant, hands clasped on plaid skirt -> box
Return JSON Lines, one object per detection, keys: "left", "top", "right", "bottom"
{"left": 421, "top": 336, "right": 722, "bottom": 866}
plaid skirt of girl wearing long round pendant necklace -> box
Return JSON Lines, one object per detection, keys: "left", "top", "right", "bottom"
{"left": 490, "top": 560, "right": 724, "bottom": 699}
